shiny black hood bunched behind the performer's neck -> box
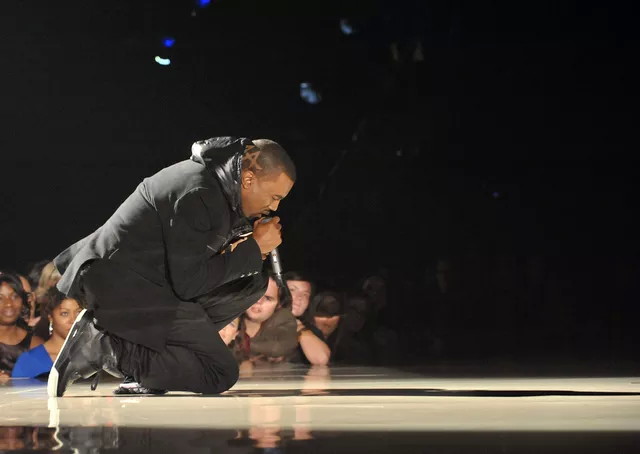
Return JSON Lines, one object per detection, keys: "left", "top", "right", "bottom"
{"left": 191, "top": 137, "right": 253, "bottom": 217}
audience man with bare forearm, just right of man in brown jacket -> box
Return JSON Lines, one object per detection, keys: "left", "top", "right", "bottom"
{"left": 284, "top": 272, "right": 331, "bottom": 366}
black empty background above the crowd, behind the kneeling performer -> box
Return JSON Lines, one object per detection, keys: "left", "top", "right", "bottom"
{"left": 0, "top": 0, "right": 640, "bottom": 361}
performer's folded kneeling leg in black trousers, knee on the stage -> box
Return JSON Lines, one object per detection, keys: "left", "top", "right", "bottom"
{"left": 113, "top": 302, "right": 238, "bottom": 394}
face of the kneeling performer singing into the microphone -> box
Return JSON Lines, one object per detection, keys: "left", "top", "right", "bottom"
{"left": 240, "top": 170, "right": 293, "bottom": 218}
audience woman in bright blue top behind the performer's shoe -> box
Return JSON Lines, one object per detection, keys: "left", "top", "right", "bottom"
{"left": 11, "top": 287, "right": 82, "bottom": 378}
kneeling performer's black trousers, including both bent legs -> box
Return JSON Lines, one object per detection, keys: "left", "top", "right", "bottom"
{"left": 110, "top": 274, "right": 268, "bottom": 394}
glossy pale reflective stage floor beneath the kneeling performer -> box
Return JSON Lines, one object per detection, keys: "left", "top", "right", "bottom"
{"left": 0, "top": 365, "right": 640, "bottom": 454}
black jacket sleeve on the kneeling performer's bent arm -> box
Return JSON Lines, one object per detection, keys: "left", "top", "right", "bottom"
{"left": 165, "top": 188, "right": 262, "bottom": 300}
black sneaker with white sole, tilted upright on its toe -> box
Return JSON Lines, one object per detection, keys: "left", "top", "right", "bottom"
{"left": 47, "top": 309, "right": 122, "bottom": 397}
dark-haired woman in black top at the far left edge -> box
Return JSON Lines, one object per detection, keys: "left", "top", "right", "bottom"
{"left": 0, "top": 273, "right": 43, "bottom": 378}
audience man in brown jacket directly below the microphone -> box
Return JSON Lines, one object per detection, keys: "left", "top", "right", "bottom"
{"left": 234, "top": 278, "right": 298, "bottom": 362}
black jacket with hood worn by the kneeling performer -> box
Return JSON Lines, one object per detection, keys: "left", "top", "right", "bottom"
{"left": 54, "top": 137, "right": 263, "bottom": 350}
